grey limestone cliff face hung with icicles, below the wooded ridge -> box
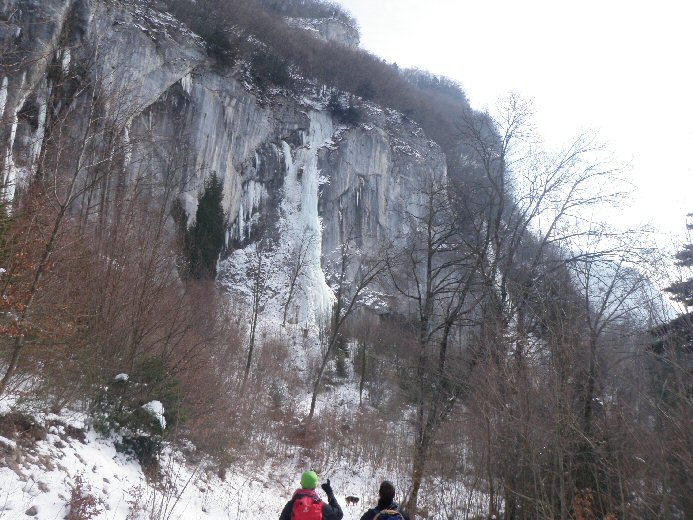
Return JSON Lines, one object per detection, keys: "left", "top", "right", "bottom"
{"left": 0, "top": 0, "right": 445, "bottom": 320}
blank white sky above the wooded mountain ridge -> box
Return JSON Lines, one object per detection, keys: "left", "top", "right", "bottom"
{"left": 338, "top": 0, "right": 693, "bottom": 243}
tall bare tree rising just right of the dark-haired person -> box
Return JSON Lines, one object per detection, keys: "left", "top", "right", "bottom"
{"left": 387, "top": 175, "right": 484, "bottom": 514}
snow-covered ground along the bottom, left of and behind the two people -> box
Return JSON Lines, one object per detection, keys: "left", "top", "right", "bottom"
{"left": 0, "top": 396, "right": 406, "bottom": 520}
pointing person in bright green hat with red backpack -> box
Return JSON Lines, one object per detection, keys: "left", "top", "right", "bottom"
{"left": 279, "top": 471, "right": 344, "bottom": 520}
